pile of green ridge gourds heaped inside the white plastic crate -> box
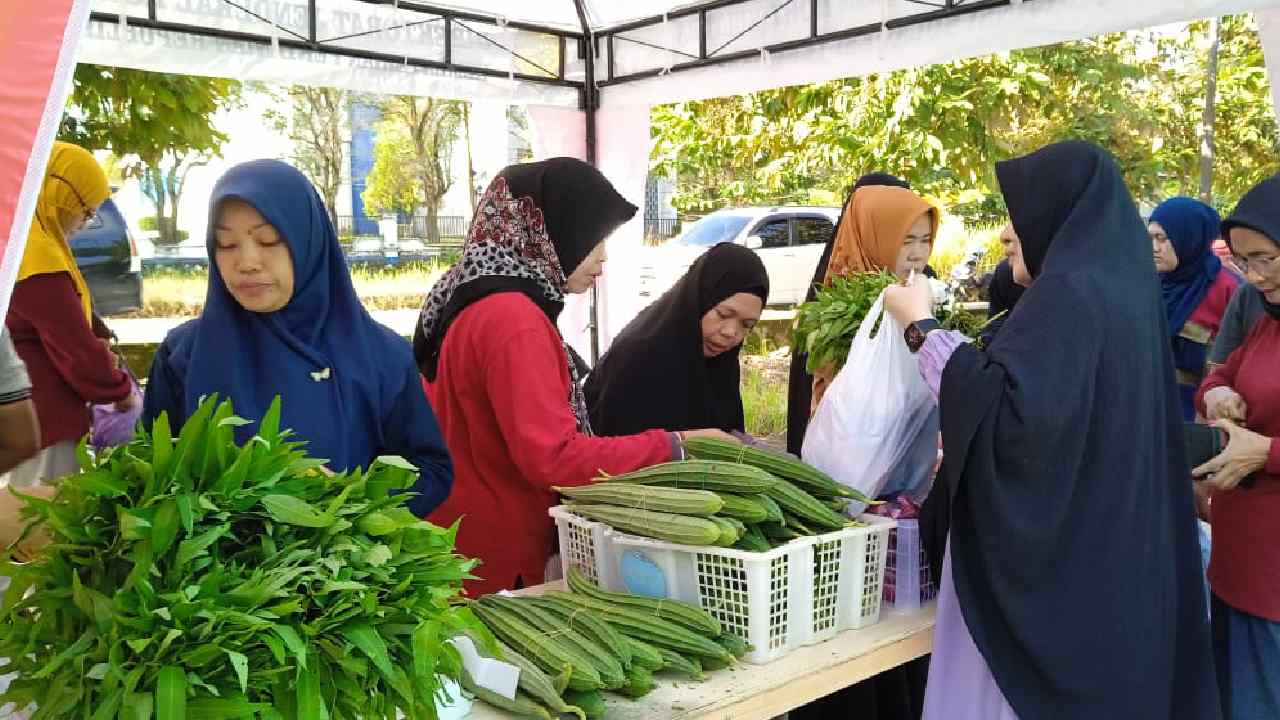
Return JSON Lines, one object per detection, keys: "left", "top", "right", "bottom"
{"left": 556, "top": 438, "right": 873, "bottom": 552}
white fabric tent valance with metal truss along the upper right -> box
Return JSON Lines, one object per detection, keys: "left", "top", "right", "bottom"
{"left": 596, "top": 0, "right": 1280, "bottom": 108}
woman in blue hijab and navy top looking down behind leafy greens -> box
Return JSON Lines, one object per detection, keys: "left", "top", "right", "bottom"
{"left": 143, "top": 160, "right": 453, "bottom": 516}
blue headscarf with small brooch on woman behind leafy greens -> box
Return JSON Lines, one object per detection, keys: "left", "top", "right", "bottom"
{"left": 169, "top": 160, "right": 413, "bottom": 470}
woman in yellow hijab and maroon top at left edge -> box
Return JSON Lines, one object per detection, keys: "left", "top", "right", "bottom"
{"left": 5, "top": 142, "right": 137, "bottom": 486}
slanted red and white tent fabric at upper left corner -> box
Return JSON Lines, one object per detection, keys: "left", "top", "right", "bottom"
{"left": 0, "top": 0, "right": 88, "bottom": 316}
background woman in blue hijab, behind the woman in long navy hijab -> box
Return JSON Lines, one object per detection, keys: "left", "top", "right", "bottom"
{"left": 1147, "top": 197, "right": 1240, "bottom": 420}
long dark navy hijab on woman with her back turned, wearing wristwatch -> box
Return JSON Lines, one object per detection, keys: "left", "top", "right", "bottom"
{"left": 941, "top": 142, "right": 1219, "bottom": 720}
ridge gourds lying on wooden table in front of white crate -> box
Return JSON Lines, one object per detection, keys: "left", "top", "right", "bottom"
{"left": 462, "top": 568, "right": 751, "bottom": 720}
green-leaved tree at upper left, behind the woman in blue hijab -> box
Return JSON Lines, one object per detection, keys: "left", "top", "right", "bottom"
{"left": 59, "top": 64, "right": 241, "bottom": 243}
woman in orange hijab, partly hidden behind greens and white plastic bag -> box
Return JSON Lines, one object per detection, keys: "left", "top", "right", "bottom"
{"left": 809, "top": 186, "right": 940, "bottom": 415}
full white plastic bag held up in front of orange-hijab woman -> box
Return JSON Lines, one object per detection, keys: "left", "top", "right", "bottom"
{"left": 801, "top": 292, "right": 934, "bottom": 511}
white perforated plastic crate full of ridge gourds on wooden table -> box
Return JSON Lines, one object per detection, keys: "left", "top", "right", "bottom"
{"left": 550, "top": 506, "right": 895, "bottom": 662}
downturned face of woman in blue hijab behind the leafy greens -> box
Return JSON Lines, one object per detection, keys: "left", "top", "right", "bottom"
{"left": 214, "top": 200, "right": 293, "bottom": 313}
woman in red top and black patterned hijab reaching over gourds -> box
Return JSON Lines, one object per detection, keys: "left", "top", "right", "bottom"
{"left": 413, "top": 158, "right": 728, "bottom": 596}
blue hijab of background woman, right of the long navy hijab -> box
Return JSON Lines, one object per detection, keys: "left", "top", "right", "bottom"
{"left": 1149, "top": 197, "right": 1222, "bottom": 420}
